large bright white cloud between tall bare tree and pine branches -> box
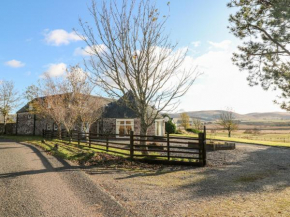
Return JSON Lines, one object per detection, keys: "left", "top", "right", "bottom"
{"left": 178, "top": 45, "right": 281, "bottom": 113}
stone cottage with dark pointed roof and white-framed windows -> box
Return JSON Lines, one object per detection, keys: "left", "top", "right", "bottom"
{"left": 16, "top": 93, "right": 165, "bottom": 137}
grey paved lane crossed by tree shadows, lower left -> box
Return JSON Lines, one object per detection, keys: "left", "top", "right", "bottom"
{"left": 0, "top": 140, "right": 125, "bottom": 217}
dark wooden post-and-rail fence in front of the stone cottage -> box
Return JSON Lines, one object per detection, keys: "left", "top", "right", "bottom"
{"left": 43, "top": 127, "right": 206, "bottom": 166}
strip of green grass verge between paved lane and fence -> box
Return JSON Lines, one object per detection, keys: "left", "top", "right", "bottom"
{"left": 0, "top": 136, "right": 195, "bottom": 168}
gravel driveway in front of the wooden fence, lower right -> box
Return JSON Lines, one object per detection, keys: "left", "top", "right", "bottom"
{"left": 86, "top": 144, "right": 290, "bottom": 216}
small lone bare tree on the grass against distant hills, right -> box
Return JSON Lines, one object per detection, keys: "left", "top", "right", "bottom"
{"left": 217, "top": 109, "right": 238, "bottom": 137}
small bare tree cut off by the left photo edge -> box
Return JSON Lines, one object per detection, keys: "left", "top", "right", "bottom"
{"left": 0, "top": 80, "right": 20, "bottom": 134}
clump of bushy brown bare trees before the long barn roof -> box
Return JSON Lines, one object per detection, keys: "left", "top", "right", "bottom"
{"left": 26, "top": 65, "right": 101, "bottom": 141}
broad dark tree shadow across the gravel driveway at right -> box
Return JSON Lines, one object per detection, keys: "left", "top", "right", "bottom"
{"left": 175, "top": 145, "right": 290, "bottom": 199}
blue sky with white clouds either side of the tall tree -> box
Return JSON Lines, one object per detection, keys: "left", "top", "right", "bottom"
{"left": 0, "top": 0, "right": 282, "bottom": 114}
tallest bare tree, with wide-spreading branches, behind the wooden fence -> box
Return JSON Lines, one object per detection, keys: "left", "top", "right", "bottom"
{"left": 79, "top": 0, "right": 198, "bottom": 139}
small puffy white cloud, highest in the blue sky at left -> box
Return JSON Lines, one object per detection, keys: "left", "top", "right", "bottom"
{"left": 44, "top": 29, "right": 82, "bottom": 46}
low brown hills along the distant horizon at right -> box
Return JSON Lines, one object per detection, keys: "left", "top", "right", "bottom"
{"left": 169, "top": 110, "right": 290, "bottom": 121}
